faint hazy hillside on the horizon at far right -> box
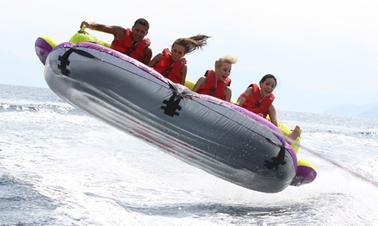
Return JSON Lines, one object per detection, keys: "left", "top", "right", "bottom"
{"left": 325, "top": 103, "right": 378, "bottom": 119}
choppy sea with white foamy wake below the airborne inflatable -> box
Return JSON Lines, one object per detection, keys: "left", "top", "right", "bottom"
{"left": 0, "top": 85, "right": 378, "bottom": 226}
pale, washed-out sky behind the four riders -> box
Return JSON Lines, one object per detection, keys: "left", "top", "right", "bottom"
{"left": 0, "top": 0, "right": 378, "bottom": 113}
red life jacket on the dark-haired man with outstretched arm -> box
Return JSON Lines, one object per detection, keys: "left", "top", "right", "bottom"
{"left": 110, "top": 28, "right": 151, "bottom": 61}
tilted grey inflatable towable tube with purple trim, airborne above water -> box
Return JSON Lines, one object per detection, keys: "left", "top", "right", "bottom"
{"left": 36, "top": 34, "right": 316, "bottom": 193}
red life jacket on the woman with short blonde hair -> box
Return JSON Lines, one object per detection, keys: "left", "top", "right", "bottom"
{"left": 198, "top": 70, "right": 231, "bottom": 100}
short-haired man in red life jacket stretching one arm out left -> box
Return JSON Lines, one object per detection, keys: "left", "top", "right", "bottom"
{"left": 80, "top": 18, "right": 152, "bottom": 65}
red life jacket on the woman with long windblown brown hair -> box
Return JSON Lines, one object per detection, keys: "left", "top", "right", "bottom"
{"left": 154, "top": 49, "right": 186, "bottom": 83}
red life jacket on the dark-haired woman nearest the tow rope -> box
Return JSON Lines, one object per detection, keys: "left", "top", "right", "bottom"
{"left": 242, "top": 84, "right": 275, "bottom": 117}
